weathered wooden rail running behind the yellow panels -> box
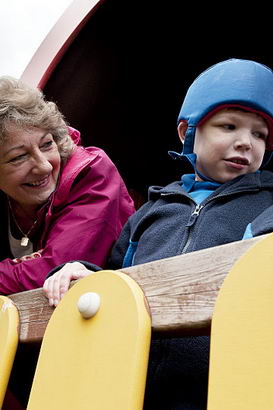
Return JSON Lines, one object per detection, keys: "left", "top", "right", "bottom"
{"left": 9, "top": 236, "right": 264, "bottom": 342}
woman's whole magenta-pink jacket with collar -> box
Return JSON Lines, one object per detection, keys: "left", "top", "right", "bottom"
{"left": 0, "top": 129, "right": 134, "bottom": 294}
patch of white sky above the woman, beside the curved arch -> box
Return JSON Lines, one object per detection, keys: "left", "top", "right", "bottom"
{"left": 0, "top": 0, "right": 72, "bottom": 78}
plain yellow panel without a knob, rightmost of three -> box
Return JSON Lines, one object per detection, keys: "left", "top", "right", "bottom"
{"left": 208, "top": 234, "right": 273, "bottom": 410}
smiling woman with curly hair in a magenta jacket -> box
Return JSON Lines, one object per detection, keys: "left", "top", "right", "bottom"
{"left": 0, "top": 77, "right": 134, "bottom": 294}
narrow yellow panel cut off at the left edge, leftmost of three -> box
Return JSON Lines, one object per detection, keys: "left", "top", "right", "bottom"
{"left": 0, "top": 296, "right": 19, "bottom": 408}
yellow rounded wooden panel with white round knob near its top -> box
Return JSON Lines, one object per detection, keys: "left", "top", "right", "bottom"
{"left": 27, "top": 271, "right": 151, "bottom": 410}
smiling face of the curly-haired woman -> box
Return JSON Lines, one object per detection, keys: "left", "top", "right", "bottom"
{"left": 0, "top": 128, "right": 61, "bottom": 211}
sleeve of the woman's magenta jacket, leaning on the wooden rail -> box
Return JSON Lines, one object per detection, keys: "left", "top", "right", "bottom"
{"left": 0, "top": 154, "right": 134, "bottom": 294}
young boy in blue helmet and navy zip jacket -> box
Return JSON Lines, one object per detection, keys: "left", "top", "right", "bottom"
{"left": 44, "top": 59, "right": 273, "bottom": 410}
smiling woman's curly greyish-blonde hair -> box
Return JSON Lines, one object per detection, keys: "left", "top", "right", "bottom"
{"left": 0, "top": 76, "right": 75, "bottom": 160}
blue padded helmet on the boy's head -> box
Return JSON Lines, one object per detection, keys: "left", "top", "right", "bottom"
{"left": 178, "top": 58, "right": 273, "bottom": 160}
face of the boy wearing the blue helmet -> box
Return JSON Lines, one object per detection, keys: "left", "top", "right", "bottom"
{"left": 184, "top": 108, "right": 268, "bottom": 183}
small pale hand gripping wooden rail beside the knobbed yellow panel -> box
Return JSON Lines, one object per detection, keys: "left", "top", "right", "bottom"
{"left": 43, "top": 262, "right": 92, "bottom": 306}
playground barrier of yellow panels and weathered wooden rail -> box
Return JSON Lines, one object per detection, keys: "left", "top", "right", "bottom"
{"left": 0, "top": 234, "right": 273, "bottom": 410}
